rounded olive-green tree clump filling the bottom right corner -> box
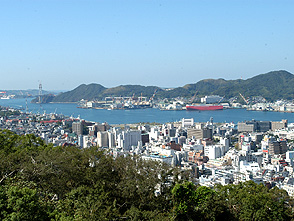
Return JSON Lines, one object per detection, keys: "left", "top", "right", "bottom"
{"left": 214, "top": 181, "right": 293, "bottom": 220}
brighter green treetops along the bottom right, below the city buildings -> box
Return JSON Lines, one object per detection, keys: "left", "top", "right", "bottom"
{"left": 172, "top": 181, "right": 293, "bottom": 220}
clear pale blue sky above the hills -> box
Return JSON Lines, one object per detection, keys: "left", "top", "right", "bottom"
{"left": 0, "top": 0, "right": 294, "bottom": 90}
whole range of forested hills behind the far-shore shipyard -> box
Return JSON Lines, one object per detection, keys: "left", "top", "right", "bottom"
{"left": 48, "top": 70, "right": 294, "bottom": 102}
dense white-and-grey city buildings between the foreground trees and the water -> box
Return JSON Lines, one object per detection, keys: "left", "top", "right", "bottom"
{"left": 0, "top": 103, "right": 294, "bottom": 196}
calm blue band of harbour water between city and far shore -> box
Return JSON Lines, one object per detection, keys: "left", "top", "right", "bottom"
{"left": 0, "top": 99, "right": 294, "bottom": 124}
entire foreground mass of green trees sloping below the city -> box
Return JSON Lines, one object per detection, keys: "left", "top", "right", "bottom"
{"left": 0, "top": 131, "right": 293, "bottom": 220}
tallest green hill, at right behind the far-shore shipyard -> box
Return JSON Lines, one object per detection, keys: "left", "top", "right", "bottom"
{"left": 178, "top": 71, "right": 294, "bottom": 101}
